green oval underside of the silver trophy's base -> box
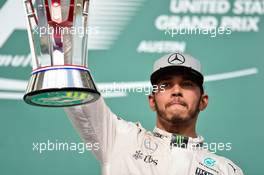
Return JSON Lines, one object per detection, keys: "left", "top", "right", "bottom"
{"left": 25, "top": 90, "right": 97, "bottom": 107}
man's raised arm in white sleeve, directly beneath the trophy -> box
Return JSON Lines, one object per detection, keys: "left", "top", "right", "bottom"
{"left": 64, "top": 97, "right": 117, "bottom": 163}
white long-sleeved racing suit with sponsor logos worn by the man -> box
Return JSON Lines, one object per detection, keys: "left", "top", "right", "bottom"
{"left": 65, "top": 97, "right": 243, "bottom": 175}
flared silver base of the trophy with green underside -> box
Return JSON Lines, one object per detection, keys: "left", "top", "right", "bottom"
{"left": 23, "top": 66, "right": 100, "bottom": 107}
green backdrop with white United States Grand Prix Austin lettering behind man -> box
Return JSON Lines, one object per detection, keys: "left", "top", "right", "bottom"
{"left": 0, "top": 0, "right": 264, "bottom": 175}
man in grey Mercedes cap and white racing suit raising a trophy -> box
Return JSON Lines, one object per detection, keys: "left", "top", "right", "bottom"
{"left": 65, "top": 53, "right": 243, "bottom": 175}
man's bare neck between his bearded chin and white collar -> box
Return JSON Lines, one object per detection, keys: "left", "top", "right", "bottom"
{"left": 156, "top": 117, "right": 197, "bottom": 138}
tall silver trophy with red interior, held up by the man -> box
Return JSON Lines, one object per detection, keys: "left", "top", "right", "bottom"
{"left": 24, "top": 0, "right": 100, "bottom": 107}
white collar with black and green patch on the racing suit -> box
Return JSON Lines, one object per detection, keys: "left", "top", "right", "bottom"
{"left": 153, "top": 127, "right": 204, "bottom": 149}
